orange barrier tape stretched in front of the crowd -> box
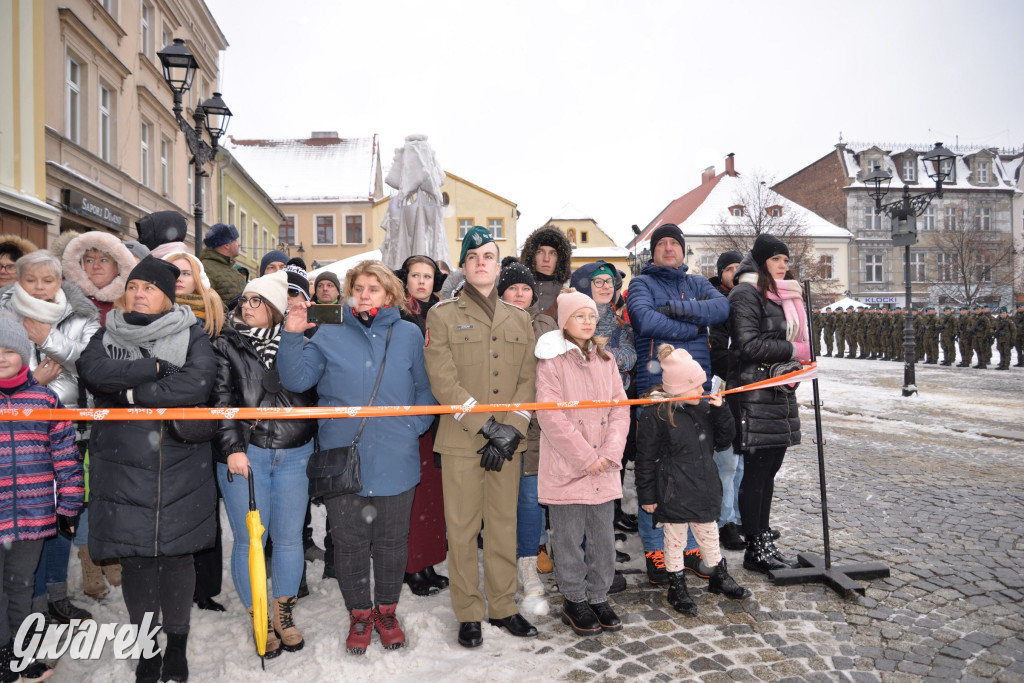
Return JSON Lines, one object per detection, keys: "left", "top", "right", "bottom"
{"left": 0, "top": 362, "right": 818, "bottom": 422}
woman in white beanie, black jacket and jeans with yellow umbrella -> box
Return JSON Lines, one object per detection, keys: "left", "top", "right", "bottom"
{"left": 212, "top": 270, "right": 316, "bottom": 657}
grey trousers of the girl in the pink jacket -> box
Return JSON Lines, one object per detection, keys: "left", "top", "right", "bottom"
{"left": 548, "top": 501, "right": 615, "bottom": 604}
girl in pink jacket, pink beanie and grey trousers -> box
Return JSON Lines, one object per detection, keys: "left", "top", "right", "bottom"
{"left": 536, "top": 291, "right": 630, "bottom": 636}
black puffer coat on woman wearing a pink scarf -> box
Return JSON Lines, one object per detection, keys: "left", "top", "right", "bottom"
{"left": 728, "top": 254, "right": 800, "bottom": 453}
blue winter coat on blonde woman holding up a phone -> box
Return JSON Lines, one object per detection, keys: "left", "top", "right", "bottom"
{"left": 278, "top": 306, "right": 437, "bottom": 497}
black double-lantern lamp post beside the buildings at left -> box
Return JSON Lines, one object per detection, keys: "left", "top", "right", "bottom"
{"left": 157, "top": 38, "right": 231, "bottom": 256}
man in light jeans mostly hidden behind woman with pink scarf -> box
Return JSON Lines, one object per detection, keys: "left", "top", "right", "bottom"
{"left": 708, "top": 251, "right": 746, "bottom": 550}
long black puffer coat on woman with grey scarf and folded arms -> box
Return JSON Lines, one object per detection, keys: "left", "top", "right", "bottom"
{"left": 78, "top": 325, "right": 217, "bottom": 560}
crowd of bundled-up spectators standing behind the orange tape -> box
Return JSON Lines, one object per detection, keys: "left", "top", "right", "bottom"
{"left": 0, "top": 220, "right": 819, "bottom": 682}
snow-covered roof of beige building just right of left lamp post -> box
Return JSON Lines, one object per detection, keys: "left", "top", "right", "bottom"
{"left": 224, "top": 135, "right": 379, "bottom": 202}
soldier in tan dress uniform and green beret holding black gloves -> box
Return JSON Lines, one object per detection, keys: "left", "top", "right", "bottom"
{"left": 424, "top": 225, "right": 537, "bottom": 647}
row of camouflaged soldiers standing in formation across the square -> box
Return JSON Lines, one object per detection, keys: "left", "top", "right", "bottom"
{"left": 814, "top": 303, "right": 1024, "bottom": 370}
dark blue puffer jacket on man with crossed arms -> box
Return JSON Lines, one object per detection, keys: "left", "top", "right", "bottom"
{"left": 626, "top": 263, "right": 729, "bottom": 395}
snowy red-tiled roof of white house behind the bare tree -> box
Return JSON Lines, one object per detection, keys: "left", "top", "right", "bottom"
{"left": 636, "top": 173, "right": 853, "bottom": 251}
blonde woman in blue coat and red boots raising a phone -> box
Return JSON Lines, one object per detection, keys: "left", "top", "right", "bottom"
{"left": 278, "top": 261, "right": 436, "bottom": 654}
